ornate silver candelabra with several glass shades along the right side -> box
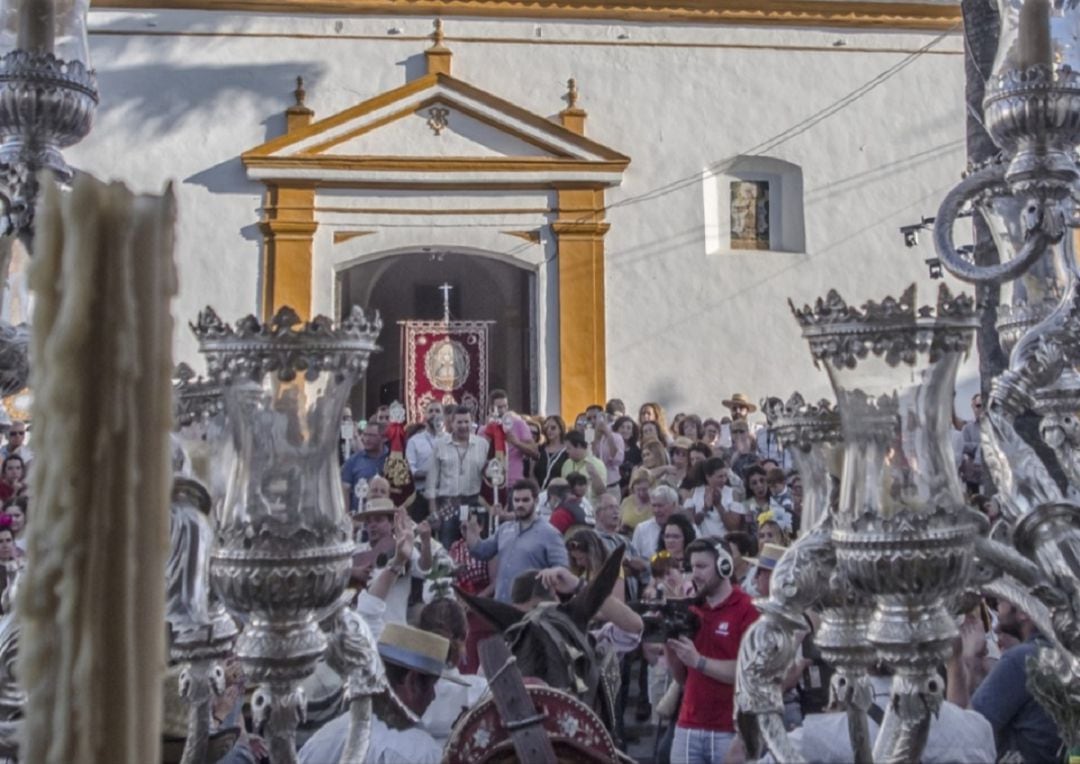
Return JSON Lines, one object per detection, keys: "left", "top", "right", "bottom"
{"left": 737, "top": 0, "right": 1080, "bottom": 762}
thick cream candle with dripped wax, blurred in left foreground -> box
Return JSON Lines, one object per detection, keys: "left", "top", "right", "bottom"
{"left": 17, "top": 176, "right": 175, "bottom": 764}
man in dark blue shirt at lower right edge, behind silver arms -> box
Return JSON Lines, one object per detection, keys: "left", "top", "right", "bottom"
{"left": 971, "top": 600, "right": 1062, "bottom": 762}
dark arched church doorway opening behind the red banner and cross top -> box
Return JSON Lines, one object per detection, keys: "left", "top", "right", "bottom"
{"left": 338, "top": 250, "right": 537, "bottom": 419}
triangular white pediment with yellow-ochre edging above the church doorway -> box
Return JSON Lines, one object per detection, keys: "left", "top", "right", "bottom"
{"left": 243, "top": 73, "right": 630, "bottom": 185}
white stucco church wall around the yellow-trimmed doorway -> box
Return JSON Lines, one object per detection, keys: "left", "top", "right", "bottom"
{"left": 67, "top": 11, "right": 980, "bottom": 413}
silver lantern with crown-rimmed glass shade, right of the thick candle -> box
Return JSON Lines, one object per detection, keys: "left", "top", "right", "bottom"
{"left": 192, "top": 308, "right": 381, "bottom": 762}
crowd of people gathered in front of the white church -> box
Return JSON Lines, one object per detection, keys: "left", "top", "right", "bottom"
{"left": 0, "top": 390, "right": 1049, "bottom": 764}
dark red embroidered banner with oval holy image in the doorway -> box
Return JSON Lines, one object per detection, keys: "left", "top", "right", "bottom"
{"left": 401, "top": 321, "right": 492, "bottom": 421}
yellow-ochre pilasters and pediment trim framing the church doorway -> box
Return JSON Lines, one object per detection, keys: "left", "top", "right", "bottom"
{"left": 242, "top": 41, "right": 630, "bottom": 417}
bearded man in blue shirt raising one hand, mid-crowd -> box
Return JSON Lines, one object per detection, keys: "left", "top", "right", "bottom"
{"left": 465, "top": 479, "right": 570, "bottom": 603}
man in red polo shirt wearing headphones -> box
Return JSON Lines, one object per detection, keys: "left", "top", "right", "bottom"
{"left": 665, "top": 539, "right": 758, "bottom": 764}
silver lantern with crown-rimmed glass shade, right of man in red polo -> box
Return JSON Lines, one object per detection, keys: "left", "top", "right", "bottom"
{"left": 795, "top": 284, "right": 978, "bottom": 761}
